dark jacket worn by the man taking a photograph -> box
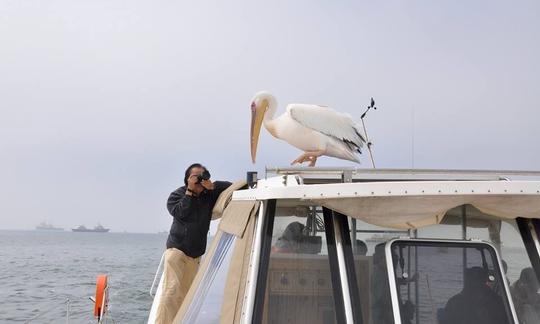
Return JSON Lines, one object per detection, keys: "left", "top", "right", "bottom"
{"left": 167, "top": 181, "right": 231, "bottom": 258}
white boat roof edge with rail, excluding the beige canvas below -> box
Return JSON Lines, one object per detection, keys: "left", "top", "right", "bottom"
{"left": 233, "top": 167, "right": 540, "bottom": 200}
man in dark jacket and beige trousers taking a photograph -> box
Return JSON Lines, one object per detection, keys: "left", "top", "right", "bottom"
{"left": 156, "top": 163, "right": 231, "bottom": 324}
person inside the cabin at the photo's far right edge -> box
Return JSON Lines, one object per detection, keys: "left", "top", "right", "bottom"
{"left": 510, "top": 268, "right": 540, "bottom": 324}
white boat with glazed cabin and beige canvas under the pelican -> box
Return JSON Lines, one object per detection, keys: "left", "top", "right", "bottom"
{"left": 144, "top": 167, "right": 540, "bottom": 324}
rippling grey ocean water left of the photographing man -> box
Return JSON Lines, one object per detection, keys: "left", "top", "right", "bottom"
{"left": 0, "top": 231, "right": 178, "bottom": 323}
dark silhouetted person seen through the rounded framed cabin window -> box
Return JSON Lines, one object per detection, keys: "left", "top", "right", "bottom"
{"left": 439, "top": 267, "right": 508, "bottom": 324}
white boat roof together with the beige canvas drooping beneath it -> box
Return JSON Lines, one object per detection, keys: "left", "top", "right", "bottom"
{"left": 233, "top": 168, "right": 540, "bottom": 229}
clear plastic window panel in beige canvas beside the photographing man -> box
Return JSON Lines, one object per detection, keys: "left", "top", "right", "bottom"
{"left": 183, "top": 232, "right": 235, "bottom": 324}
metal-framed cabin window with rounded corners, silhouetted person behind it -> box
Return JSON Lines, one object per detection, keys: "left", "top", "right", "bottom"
{"left": 386, "top": 240, "right": 513, "bottom": 324}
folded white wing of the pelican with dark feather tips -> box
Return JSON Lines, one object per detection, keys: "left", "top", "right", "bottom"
{"left": 287, "top": 104, "right": 366, "bottom": 152}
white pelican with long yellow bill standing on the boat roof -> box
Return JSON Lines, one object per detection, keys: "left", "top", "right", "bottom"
{"left": 251, "top": 91, "right": 366, "bottom": 166}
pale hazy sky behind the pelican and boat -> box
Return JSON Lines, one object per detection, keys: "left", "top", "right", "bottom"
{"left": 0, "top": 0, "right": 540, "bottom": 232}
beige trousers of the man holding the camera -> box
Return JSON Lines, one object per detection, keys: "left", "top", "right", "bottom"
{"left": 155, "top": 248, "right": 200, "bottom": 324}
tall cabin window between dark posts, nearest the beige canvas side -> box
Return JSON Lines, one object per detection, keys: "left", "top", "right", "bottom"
{"left": 262, "top": 205, "right": 336, "bottom": 324}
